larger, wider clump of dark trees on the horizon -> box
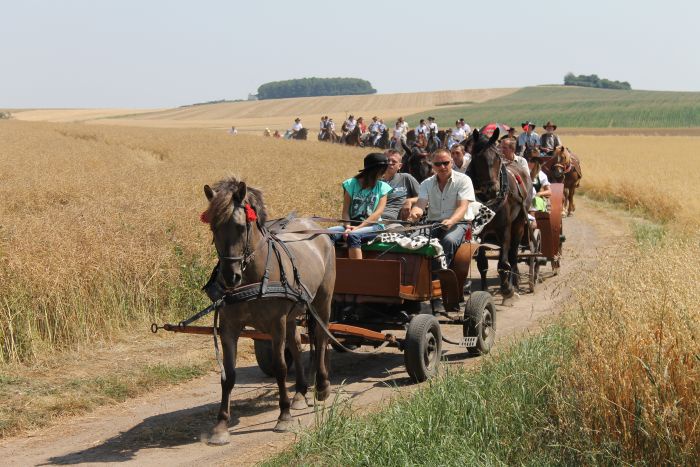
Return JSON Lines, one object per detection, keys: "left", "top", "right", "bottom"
{"left": 258, "top": 78, "right": 377, "bottom": 100}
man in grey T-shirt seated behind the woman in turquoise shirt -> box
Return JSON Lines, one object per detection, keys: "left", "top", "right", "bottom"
{"left": 382, "top": 149, "right": 420, "bottom": 220}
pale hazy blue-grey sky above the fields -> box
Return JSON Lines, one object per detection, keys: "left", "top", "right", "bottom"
{"left": 0, "top": 0, "right": 700, "bottom": 108}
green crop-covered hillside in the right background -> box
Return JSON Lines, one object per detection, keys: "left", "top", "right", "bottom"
{"left": 408, "top": 86, "right": 700, "bottom": 128}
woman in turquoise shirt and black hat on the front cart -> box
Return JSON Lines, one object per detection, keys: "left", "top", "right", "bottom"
{"left": 331, "top": 152, "right": 392, "bottom": 259}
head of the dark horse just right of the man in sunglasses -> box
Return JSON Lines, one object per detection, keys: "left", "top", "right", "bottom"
{"left": 468, "top": 128, "right": 502, "bottom": 201}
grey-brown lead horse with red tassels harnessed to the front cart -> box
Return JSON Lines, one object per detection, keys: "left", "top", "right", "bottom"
{"left": 204, "top": 177, "right": 335, "bottom": 444}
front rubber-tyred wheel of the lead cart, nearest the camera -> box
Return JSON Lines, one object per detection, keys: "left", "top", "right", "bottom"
{"left": 403, "top": 315, "right": 442, "bottom": 383}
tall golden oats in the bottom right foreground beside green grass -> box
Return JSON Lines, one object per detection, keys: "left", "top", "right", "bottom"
{"left": 560, "top": 238, "right": 700, "bottom": 465}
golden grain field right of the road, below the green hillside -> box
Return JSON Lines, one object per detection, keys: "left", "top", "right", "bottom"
{"left": 565, "top": 136, "right": 700, "bottom": 229}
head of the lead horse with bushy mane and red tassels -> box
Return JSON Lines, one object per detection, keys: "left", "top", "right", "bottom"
{"left": 203, "top": 177, "right": 267, "bottom": 288}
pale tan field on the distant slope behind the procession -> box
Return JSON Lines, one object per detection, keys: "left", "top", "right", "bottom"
{"left": 13, "top": 88, "right": 517, "bottom": 133}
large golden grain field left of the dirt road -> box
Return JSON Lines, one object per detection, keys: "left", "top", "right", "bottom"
{"left": 0, "top": 121, "right": 364, "bottom": 362}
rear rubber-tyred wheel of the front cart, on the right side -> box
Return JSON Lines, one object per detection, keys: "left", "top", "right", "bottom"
{"left": 462, "top": 291, "right": 496, "bottom": 354}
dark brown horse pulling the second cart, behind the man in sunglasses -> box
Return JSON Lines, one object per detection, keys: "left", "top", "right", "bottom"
{"left": 465, "top": 129, "right": 532, "bottom": 300}
